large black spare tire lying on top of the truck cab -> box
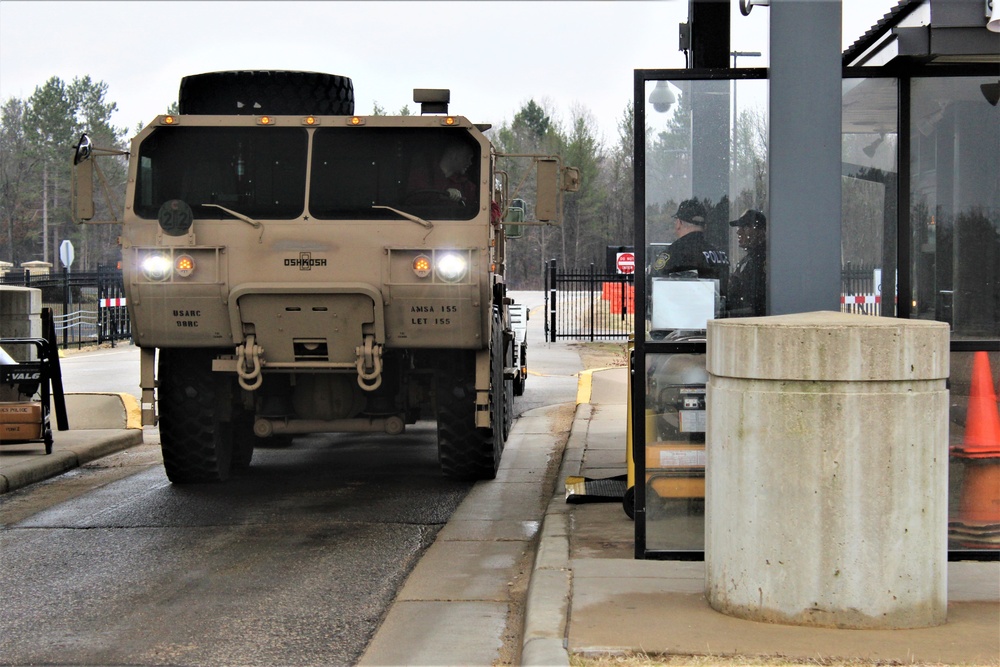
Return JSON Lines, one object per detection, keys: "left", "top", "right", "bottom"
{"left": 177, "top": 70, "right": 354, "bottom": 116}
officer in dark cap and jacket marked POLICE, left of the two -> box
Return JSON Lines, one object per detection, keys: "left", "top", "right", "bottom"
{"left": 650, "top": 199, "right": 729, "bottom": 296}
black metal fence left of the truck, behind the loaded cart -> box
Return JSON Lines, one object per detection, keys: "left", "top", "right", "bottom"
{"left": 0, "top": 265, "right": 132, "bottom": 348}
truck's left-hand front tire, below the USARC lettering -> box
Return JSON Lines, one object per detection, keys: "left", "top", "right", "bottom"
{"left": 157, "top": 349, "right": 233, "bottom": 484}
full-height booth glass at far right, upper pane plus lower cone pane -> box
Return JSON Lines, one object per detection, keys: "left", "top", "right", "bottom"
{"left": 907, "top": 76, "right": 1000, "bottom": 553}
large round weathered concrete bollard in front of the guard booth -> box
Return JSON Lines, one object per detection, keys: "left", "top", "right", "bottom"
{"left": 705, "top": 312, "right": 949, "bottom": 629}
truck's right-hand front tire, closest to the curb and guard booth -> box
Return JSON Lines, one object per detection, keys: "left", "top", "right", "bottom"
{"left": 435, "top": 309, "right": 508, "bottom": 481}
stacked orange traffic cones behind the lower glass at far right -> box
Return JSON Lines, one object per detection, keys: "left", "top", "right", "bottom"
{"left": 949, "top": 351, "right": 1000, "bottom": 549}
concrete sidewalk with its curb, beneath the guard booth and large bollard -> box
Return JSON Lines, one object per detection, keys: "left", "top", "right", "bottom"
{"left": 522, "top": 369, "right": 1000, "bottom": 665}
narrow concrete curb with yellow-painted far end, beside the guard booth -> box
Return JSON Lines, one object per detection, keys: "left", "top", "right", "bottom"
{"left": 521, "top": 402, "right": 593, "bottom": 667}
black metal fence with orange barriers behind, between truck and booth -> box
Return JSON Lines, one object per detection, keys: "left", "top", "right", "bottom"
{"left": 545, "top": 259, "right": 635, "bottom": 342}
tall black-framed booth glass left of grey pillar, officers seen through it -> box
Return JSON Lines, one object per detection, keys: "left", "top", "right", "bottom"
{"left": 626, "top": 69, "right": 768, "bottom": 557}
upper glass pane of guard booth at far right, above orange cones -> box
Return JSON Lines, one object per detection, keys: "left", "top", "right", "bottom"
{"left": 909, "top": 76, "right": 1000, "bottom": 340}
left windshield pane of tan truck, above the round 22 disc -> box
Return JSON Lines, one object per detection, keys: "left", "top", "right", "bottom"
{"left": 134, "top": 126, "right": 309, "bottom": 220}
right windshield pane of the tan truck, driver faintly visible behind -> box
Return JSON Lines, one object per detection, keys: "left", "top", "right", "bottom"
{"left": 309, "top": 127, "right": 481, "bottom": 220}
